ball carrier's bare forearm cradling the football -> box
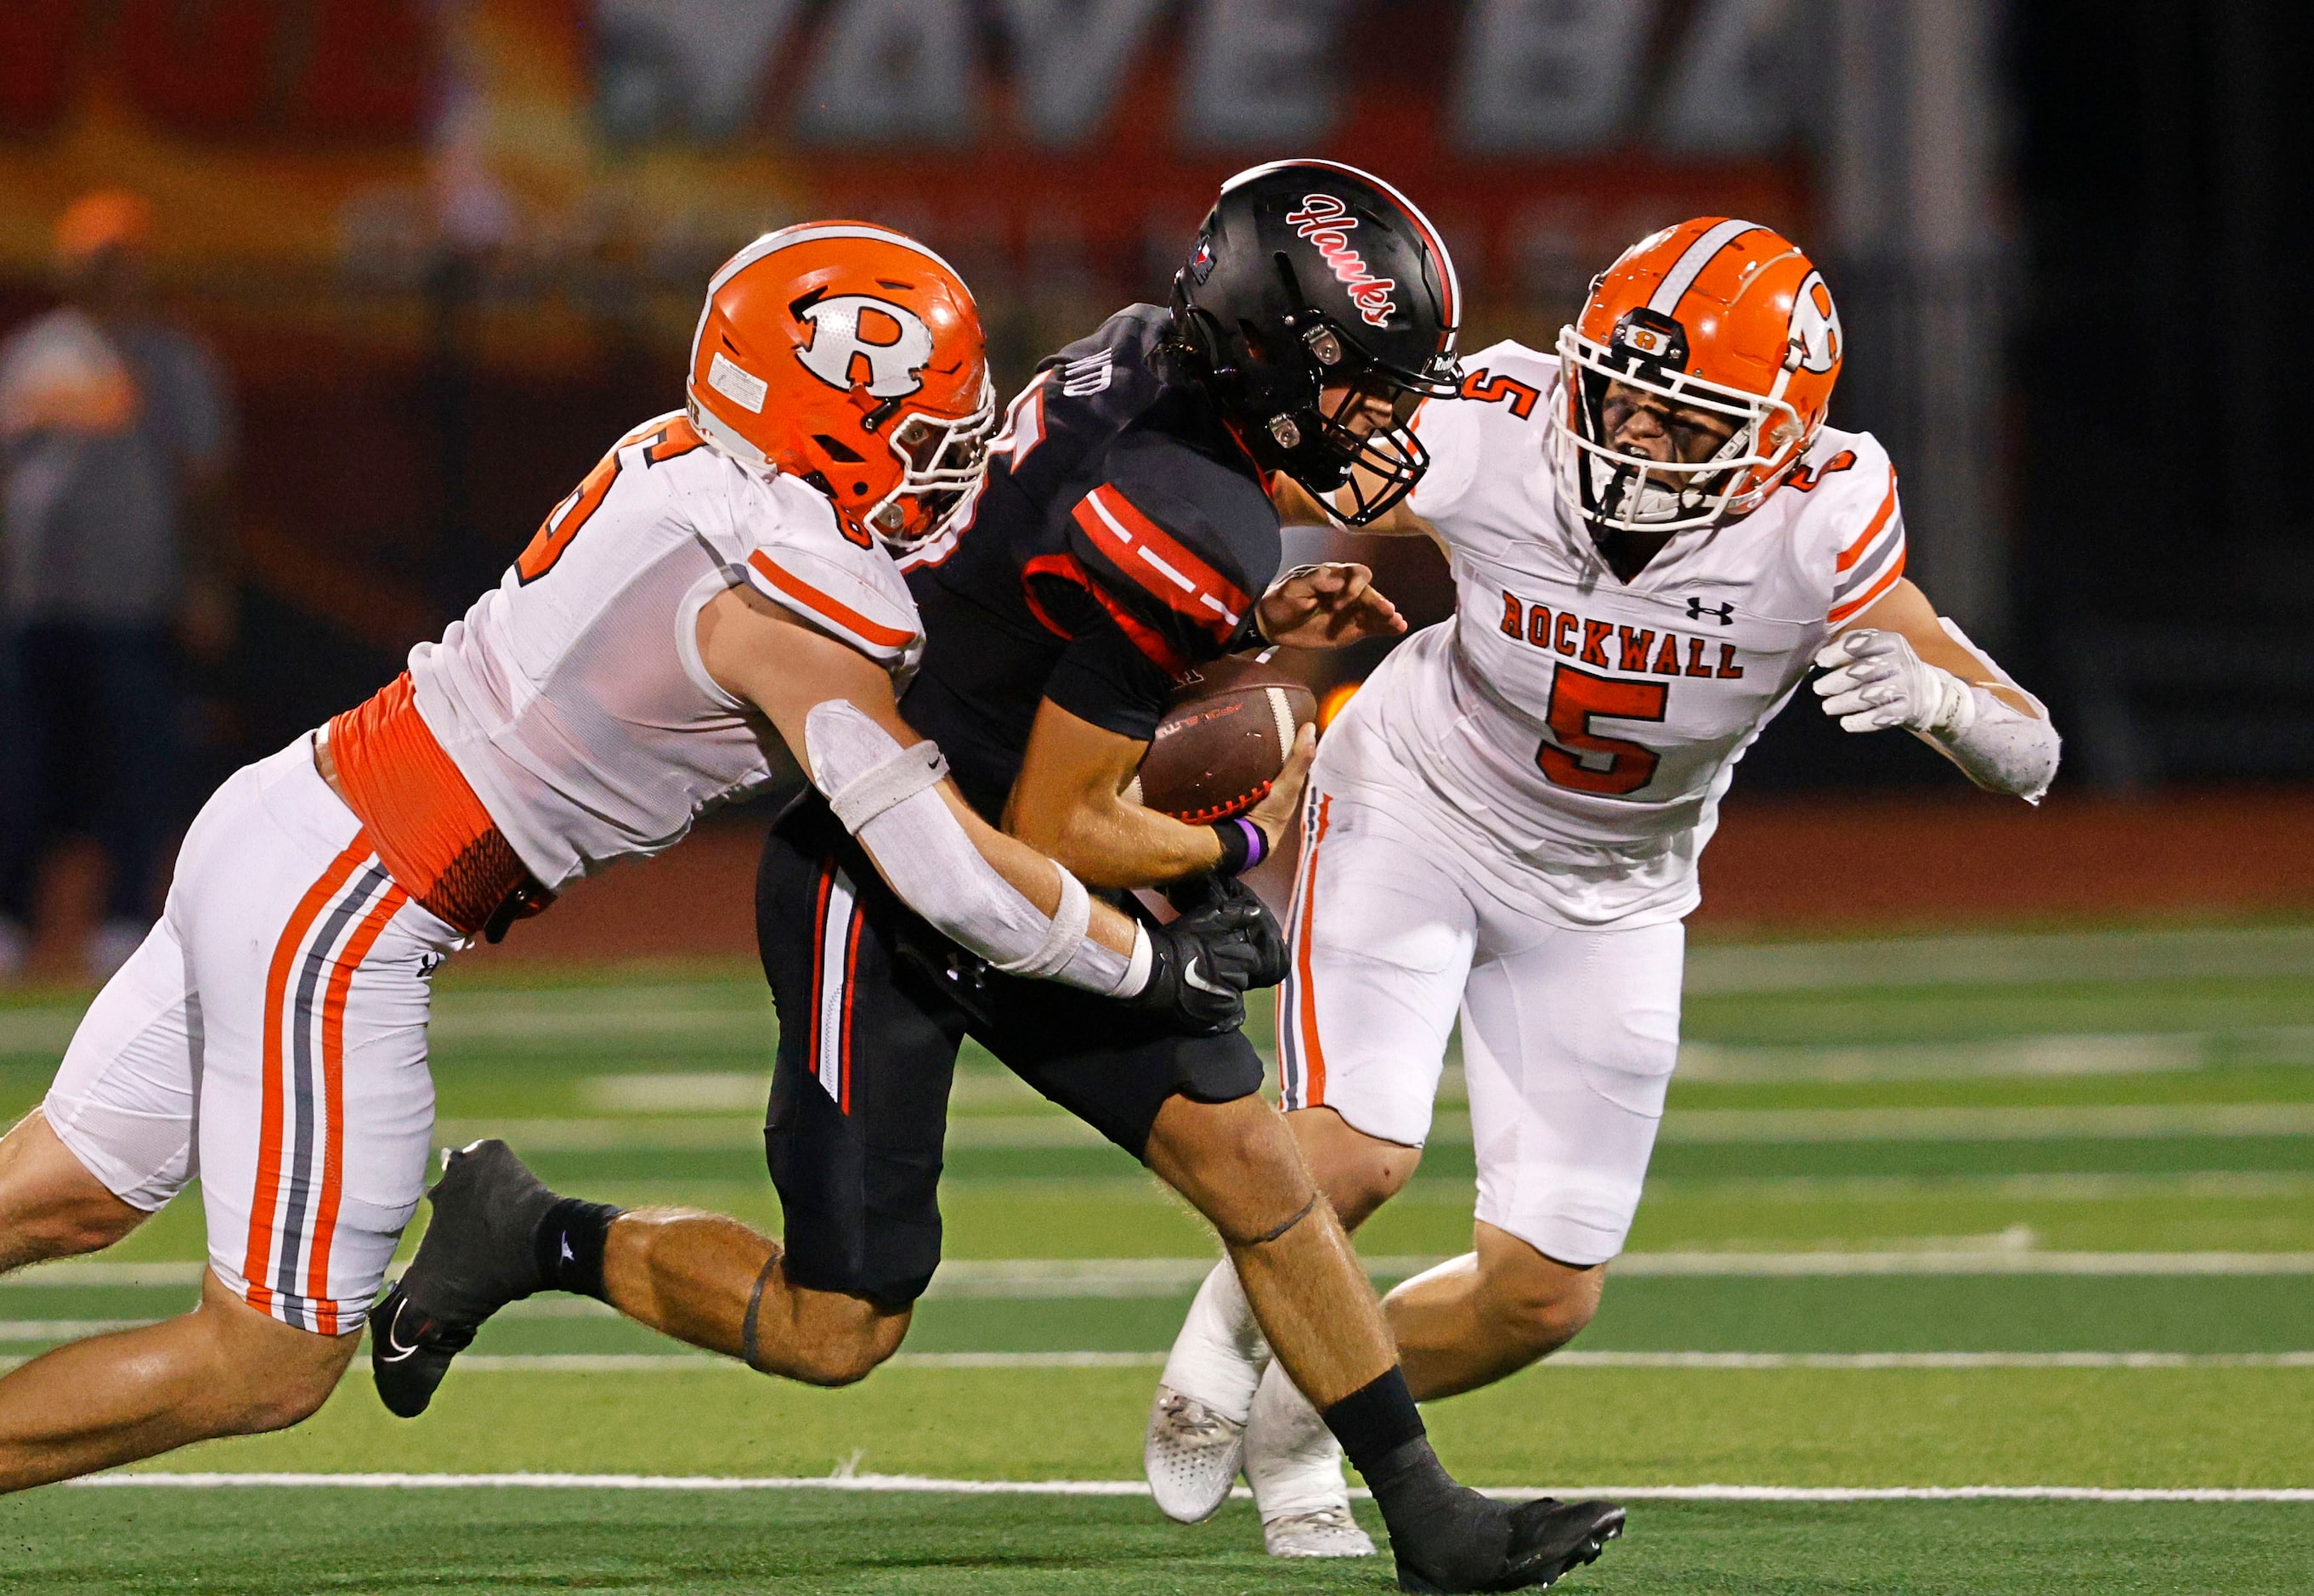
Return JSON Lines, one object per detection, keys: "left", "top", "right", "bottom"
{"left": 1004, "top": 699, "right": 1222, "bottom": 888}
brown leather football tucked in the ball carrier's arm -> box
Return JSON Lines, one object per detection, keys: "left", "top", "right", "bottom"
{"left": 1124, "top": 653, "right": 1316, "bottom": 826}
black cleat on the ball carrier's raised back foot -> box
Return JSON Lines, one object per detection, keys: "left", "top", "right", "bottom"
{"left": 371, "top": 1140, "right": 563, "bottom": 1418}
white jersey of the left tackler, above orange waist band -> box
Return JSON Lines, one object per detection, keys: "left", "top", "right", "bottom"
{"left": 410, "top": 411, "right": 923, "bottom": 891}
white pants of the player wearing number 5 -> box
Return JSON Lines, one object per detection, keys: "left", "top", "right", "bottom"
{"left": 1277, "top": 782, "right": 1687, "bottom": 1265}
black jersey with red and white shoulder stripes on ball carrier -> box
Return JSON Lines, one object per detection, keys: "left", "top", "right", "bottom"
{"left": 900, "top": 305, "right": 1280, "bottom": 821}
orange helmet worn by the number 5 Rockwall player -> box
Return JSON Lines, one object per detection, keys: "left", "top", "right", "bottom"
{"left": 1550, "top": 215, "right": 1842, "bottom": 532}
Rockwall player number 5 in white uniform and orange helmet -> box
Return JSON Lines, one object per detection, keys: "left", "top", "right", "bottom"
{"left": 1150, "top": 218, "right": 2057, "bottom": 1557}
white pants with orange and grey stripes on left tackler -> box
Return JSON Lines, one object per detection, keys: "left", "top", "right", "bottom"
{"left": 44, "top": 738, "right": 461, "bottom": 1334}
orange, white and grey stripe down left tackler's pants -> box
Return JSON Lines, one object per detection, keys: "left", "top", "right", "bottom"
{"left": 240, "top": 833, "right": 410, "bottom": 1334}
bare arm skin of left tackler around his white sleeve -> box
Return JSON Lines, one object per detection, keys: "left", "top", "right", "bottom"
{"left": 699, "top": 587, "right": 1134, "bottom": 955}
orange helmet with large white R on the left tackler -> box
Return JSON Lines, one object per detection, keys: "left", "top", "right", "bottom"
{"left": 687, "top": 222, "right": 998, "bottom": 551}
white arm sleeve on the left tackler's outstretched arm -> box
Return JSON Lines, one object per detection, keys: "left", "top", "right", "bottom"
{"left": 803, "top": 699, "right": 1150, "bottom": 997}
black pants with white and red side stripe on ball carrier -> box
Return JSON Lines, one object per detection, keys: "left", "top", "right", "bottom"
{"left": 755, "top": 794, "right": 1261, "bottom": 1307}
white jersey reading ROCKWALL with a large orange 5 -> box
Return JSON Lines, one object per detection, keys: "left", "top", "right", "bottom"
{"left": 1319, "top": 342, "right": 1904, "bottom": 925}
